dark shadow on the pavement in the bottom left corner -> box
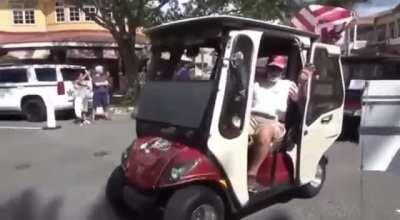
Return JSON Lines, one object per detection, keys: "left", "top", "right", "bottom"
{"left": 0, "top": 189, "right": 63, "bottom": 220}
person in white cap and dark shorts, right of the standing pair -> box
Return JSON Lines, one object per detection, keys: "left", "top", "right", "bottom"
{"left": 93, "top": 65, "right": 111, "bottom": 120}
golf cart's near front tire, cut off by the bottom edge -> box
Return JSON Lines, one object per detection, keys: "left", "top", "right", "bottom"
{"left": 164, "top": 185, "right": 225, "bottom": 220}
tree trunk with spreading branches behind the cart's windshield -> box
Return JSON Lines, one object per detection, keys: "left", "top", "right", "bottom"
{"left": 67, "top": 0, "right": 168, "bottom": 99}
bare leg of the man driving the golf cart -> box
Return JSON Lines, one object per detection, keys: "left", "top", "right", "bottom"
{"left": 248, "top": 123, "right": 275, "bottom": 176}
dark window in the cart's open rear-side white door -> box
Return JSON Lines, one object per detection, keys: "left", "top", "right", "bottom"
{"left": 306, "top": 48, "right": 344, "bottom": 125}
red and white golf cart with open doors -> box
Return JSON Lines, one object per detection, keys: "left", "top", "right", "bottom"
{"left": 106, "top": 16, "right": 344, "bottom": 220}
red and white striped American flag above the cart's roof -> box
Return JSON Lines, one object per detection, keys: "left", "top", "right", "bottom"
{"left": 291, "top": 5, "right": 353, "bottom": 43}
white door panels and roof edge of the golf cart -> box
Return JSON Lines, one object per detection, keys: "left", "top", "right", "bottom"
{"left": 148, "top": 16, "right": 344, "bottom": 207}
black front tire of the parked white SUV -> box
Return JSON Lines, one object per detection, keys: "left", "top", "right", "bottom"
{"left": 22, "top": 98, "right": 47, "bottom": 122}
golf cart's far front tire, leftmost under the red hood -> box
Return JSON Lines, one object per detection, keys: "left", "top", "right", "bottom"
{"left": 106, "top": 166, "right": 127, "bottom": 210}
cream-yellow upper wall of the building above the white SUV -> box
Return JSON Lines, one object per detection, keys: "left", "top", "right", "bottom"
{"left": 0, "top": 0, "right": 104, "bottom": 32}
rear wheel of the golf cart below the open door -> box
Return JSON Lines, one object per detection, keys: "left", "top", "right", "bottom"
{"left": 299, "top": 157, "right": 327, "bottom": 198}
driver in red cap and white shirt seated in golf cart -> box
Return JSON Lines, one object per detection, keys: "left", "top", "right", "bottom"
{"left": 248, "top": 56, "right": 299, "bottom": 183}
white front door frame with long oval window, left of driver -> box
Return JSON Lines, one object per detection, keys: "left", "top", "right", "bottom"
{"left": 207, "top": 30, "right": 262, "bottom": 206}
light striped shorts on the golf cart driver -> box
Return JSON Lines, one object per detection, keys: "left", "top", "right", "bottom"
{"left": 249, "top": 114, "right": 286, "bottom": 143}
